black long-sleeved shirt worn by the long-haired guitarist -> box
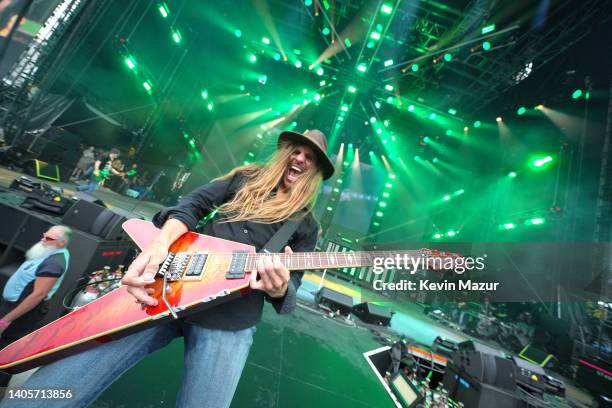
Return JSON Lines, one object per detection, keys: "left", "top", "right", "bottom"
{"left": 153, "top": 173, "right": 319, "bottom": 330}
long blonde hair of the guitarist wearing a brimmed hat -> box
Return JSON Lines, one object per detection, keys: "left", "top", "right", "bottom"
{"left": 218, "top": 143, "right": 323, "bottom": 223}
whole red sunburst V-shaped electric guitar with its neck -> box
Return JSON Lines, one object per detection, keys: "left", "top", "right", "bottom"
{"left": 0, "top": 219, "right": 456, "bottom": 374}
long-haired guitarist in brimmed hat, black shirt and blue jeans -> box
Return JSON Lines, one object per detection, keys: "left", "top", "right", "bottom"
{"left": 2, "top": 130, "right": 334, "bottom": 408}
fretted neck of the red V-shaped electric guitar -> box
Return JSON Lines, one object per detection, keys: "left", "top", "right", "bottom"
{"left": 245, "top": 249, "right": 432, "bottom": 271}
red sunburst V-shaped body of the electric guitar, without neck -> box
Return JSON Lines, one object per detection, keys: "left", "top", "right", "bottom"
{"left": 0, "top": 220, "right": 255, "bottom": 374}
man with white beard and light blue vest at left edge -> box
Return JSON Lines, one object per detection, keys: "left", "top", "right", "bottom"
{"left": 0, "top": 226, "right": 72, "bottom": 340}
